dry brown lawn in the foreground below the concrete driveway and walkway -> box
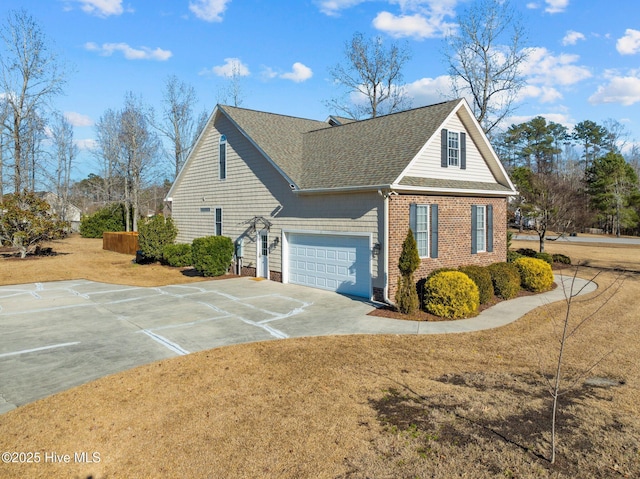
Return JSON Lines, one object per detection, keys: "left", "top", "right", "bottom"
{"left": 0, "top": 237, "right": 640, "bottom": 478}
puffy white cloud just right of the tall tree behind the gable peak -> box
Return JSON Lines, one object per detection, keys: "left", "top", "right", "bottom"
{"left": 522, "top": 47, "right": 592, "bottom": 86}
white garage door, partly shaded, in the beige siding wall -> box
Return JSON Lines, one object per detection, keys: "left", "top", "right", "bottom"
{"left": 288, "top": 233, "right": 371, "bottom": 298}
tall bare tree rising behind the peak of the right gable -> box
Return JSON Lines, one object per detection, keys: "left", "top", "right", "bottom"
{"left": 445, "top": 0, "right": 527, "bottom": 134}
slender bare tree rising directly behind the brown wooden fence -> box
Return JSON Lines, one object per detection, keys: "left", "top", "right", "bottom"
{"left": 119, "top": 92, "right": 160, "bottom": 231}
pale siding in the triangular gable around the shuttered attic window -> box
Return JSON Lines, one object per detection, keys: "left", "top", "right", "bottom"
{"left": 404, "top": 115, "right": 496, "bottom": 183}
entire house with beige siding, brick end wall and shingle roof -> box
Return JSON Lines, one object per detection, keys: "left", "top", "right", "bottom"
{"left": 166, "top": 99, "right": 516, "bottom": 301}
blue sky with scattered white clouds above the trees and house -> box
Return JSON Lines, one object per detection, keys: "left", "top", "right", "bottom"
{"left": 0, "top": 0, "right": 640, "bottom": 179}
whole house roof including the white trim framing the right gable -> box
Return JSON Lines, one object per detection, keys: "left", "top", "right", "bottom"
{"left": 169, "top": 99, "right": 515, "bottom": 196}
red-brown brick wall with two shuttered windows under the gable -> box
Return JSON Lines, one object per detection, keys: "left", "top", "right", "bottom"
{"left": 389, "top": 195, "right": 507, "bottom": 301}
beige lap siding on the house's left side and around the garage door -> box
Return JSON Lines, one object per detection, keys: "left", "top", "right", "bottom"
{"left": 171, "top": 115, "right": 384, "bottom": 288}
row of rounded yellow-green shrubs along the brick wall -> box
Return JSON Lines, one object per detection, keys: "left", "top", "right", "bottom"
{"left": 418, "top": 256, "right": 553, "bottom": 319}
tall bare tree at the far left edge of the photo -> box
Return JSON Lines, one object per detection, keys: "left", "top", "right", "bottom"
{"left": 0, "top": 10, "right": 65, "bottom": 193}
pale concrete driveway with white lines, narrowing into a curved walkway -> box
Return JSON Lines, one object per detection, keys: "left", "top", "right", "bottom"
{"left": 0, "top": 277, "right": 595, "bottom": 414}
